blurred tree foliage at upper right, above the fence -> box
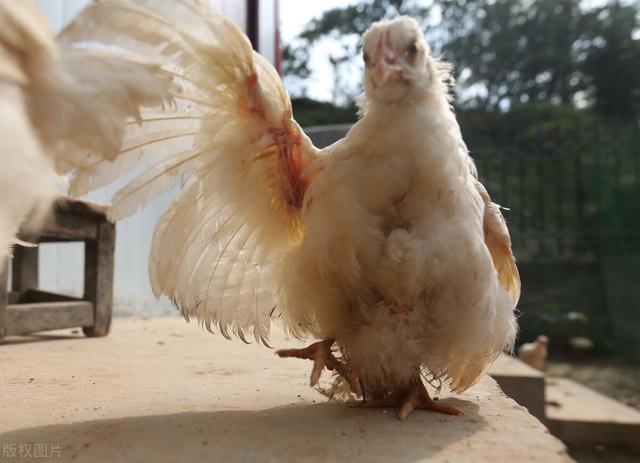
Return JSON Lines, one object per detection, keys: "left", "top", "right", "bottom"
{"left": 443, "top": 0, "right": 640, "bottom": 115}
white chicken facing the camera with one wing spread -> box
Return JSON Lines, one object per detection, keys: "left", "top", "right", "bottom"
{"left": 62, "top": 0, "right": 520, "bottom": 420}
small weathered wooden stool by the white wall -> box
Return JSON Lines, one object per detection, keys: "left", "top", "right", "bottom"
{"left": 0, "top": 197, "right": 115, "bottom": 339}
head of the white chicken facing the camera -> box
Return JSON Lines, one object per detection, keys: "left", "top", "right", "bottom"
{"left": 362, "top": 16, "right": 439, "bottom": 103}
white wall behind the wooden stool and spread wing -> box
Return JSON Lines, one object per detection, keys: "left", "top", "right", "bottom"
{"left": 35, "top": 0, "right": 275, "bottom": 315}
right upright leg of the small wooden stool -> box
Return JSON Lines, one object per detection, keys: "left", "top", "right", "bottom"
{"left": 82, "top": 221, "right": 116, "bottom": 336}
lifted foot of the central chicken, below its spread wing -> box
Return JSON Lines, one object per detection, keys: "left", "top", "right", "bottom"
{"left": 276, "top": 339, "right": 362, "bottom": 395}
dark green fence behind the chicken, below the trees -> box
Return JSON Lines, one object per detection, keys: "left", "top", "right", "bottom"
{"left": 305, "top": 118, "right": 640, "bottom": 358}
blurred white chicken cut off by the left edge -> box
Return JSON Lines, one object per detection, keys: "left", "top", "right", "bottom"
{"left": 0, "top": 0, "right": 169, "bottom": 262}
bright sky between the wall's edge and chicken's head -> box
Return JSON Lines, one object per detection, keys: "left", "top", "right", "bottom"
{"left": 280, "top": 0, "right": 359, "bottom": 101}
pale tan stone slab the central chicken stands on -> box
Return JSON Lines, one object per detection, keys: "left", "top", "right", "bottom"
{"left": 0, "top": 318, "right": 571, "bottom": 463}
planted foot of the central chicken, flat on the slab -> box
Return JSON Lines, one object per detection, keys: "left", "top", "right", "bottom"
{"left": 362, "top": 375, "right": 464, "bottom": 421}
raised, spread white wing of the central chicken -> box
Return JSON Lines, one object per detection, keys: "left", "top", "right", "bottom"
{"left": 61, "top": 0, "right": 317, "bottom": 342}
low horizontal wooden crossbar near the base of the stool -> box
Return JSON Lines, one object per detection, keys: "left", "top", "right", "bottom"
{"left": 6, "top": 301, "right": 93, "bottom": 336}
